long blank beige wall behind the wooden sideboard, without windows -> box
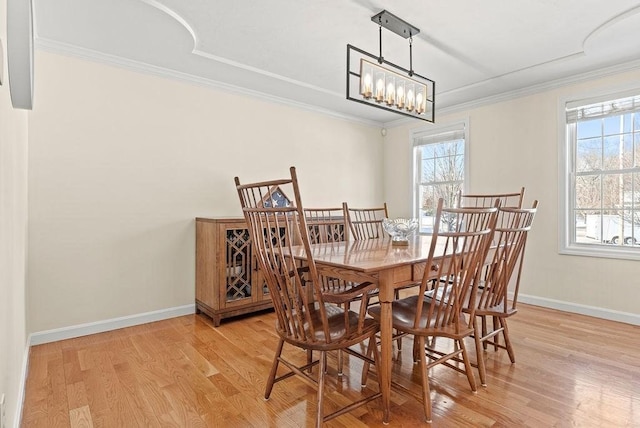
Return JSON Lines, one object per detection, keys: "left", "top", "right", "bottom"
{"left": 28, "top": 52, "right": 383, "bottom": 332}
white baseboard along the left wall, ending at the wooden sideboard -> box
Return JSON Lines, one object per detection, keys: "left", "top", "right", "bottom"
{"left": 28, "top": 304, "right": 196, "bottom": 345}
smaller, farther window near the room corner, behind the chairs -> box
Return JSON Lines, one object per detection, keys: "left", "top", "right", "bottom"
{"left": 412, "top": 121, "right": 467, "bottom": 233}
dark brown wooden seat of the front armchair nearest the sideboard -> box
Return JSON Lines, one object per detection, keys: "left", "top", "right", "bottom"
{"left": 277, "top": 303, "right": 379, "bottom": 351}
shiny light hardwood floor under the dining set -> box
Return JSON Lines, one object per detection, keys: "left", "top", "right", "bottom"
{"left": 21, "top": 305, "right": 640, "bottom": 428}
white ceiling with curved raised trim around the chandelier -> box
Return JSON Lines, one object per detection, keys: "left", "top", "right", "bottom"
{"left": 33, "top": 0, "right": 640, "bottom": 124}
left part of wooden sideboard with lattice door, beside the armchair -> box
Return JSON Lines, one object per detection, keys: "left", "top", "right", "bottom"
{"left": 196, "top": 217, "right": 273, "bottom": 327}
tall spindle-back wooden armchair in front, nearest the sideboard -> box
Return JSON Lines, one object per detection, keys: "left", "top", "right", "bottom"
{"left": 235, "top": 167, "right": 381, "bottom": 427}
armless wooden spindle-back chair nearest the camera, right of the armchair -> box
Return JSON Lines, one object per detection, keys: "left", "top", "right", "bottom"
{"left": 362, "top": 199, "right": 498, "bottom": 422}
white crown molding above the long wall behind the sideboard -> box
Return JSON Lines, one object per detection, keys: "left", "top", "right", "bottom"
{"left": 35, "top": 38, "right": 382, "bottom": 127}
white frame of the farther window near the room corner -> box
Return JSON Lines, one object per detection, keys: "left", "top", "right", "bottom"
{"left": 410, "top": 118, "right": 469, "bottom": 234}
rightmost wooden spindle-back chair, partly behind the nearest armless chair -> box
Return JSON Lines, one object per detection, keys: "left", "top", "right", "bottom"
{"left": 465, "top": 201, "right": 538, "bottom": 386}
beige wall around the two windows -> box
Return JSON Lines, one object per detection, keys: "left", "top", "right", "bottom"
{"left": 384, "top": 71, "right": 640, "bottom": 319}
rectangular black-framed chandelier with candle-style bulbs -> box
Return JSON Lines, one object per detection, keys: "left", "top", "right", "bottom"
{"left": 347, "top": 10, "right": 436, "bottom": 123}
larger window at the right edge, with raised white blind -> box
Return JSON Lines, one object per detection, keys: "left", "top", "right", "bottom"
{"left": 561, "top": 91, "right": 640, "bottom": 259}
